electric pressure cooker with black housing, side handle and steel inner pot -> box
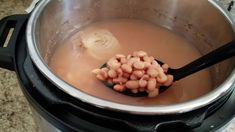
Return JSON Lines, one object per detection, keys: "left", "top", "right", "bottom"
{"left": 0, "top": 0, "right": 235, "bottom": 132}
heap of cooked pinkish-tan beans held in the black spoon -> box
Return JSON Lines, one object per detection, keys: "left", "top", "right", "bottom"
{"left": 92, "top": 51, "right": 173, "bottom": 97}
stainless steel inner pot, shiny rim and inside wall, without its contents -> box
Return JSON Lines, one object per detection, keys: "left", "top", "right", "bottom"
{"left": 27, "top": 0, "right": 235, "bottom": 115}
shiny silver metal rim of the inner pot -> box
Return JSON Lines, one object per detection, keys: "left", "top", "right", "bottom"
{"left": 27, "top": 0, "right": 235, "bottom": 115}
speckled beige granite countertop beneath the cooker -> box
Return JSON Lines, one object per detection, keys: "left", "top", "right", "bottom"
{"left": 0, "top": 0, "right": 231, "bottom": 132}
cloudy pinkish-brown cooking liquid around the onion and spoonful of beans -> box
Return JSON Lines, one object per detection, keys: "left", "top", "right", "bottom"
{"left": 49, "top": 19, "right": 211, "bottom": 105}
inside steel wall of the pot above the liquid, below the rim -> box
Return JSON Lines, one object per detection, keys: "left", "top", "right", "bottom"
{"left": 36, "top": 0, "right": 235, "bottom": 87}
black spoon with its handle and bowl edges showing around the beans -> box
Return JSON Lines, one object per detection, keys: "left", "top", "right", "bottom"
{"left": 101, "top": 40, "right": 235, "bottom": 97}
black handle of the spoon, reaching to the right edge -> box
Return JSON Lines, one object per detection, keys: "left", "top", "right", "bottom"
{"left": 172, "top": 40, "right": 235, "bottom": 81}
